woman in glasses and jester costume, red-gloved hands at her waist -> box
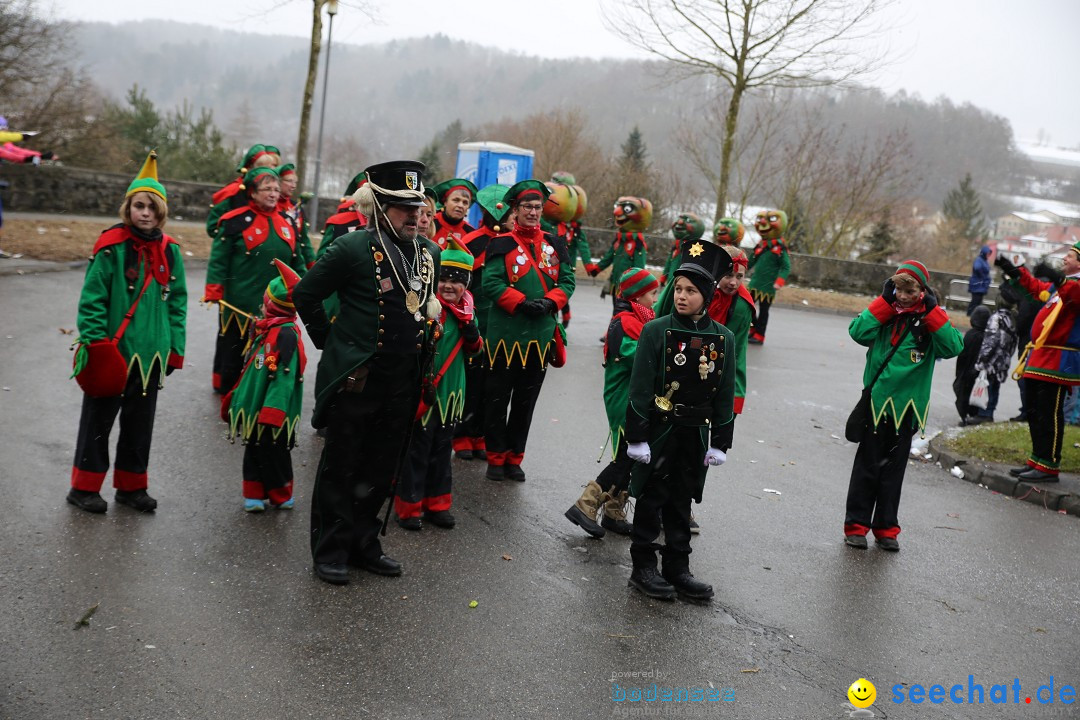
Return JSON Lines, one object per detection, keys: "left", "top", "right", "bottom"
{"left": 484, "top": 180, "right": 576, "bottom": 481}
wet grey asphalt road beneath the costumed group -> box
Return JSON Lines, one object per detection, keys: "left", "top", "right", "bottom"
{"left": 0, "top": 268, "right": 1080, "bottom": 719}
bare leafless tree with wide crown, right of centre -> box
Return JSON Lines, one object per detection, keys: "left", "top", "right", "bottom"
{"left": 604, "top": 0, "right": 891, "bottom": 219}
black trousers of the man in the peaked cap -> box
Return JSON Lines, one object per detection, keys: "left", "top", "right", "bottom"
{"left": 311, "top": 355, "right": 420, "bottom": 565}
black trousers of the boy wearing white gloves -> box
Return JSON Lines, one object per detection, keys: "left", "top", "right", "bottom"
{"left": 630, "top": 427, "right": 704, "bottom": 573}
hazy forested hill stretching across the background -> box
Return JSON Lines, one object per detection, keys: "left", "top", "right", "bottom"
{"left": 75, "top": 21, "right": 1025, "bottom": 206}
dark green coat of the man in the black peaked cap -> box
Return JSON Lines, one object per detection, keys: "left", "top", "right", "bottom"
{"left": 293, "top": 229, "right": 440, "bottom": 427}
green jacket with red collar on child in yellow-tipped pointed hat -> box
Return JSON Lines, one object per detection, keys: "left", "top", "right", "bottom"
{"left": 77, "top": 225, "right": 188, "bottom": 389}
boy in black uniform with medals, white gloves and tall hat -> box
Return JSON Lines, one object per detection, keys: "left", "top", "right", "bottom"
{"left": 626, "top": 240, "right": 735, "bottom": 600}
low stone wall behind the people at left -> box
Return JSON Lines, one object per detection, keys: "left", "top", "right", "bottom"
{"left": 0, "top": 164, "right": 340, "bottom": 229}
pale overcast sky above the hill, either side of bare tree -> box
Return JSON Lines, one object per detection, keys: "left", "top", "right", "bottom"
{"left": 41, "top": 0, "right": 1080, "bottom": 148}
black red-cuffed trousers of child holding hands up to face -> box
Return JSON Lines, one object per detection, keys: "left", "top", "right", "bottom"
{"left": 843, "top": 413, "right": 916, "bottom": 538}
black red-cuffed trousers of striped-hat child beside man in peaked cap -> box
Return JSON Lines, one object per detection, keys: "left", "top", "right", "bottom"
{"left": 394, "top": 416, "right": 454, "bottom": 518}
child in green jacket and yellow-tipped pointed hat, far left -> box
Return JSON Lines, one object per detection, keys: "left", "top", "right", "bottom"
{"left": 67, "top": 151, "right": 188, "bottom": 513}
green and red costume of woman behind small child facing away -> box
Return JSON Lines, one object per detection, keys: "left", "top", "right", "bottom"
{"left": 203, "top": 167, "right": 307, "bottom": 395}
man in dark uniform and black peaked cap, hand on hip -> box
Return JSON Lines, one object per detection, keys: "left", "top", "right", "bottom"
{"left": 294, "top": 161, "right": 441, "bottom": 585}
